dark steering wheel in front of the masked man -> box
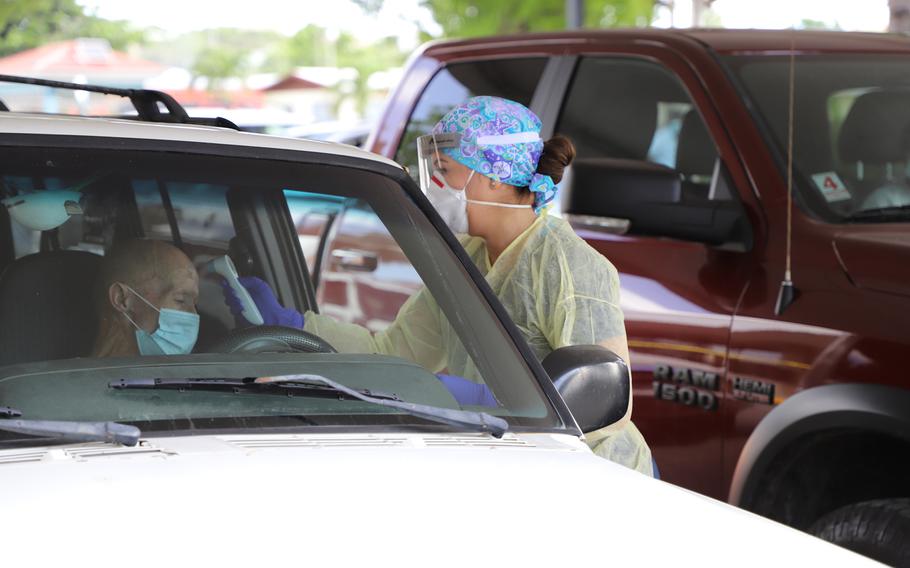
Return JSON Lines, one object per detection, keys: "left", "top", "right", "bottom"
{"left": 206, "top": 325, "right": 338, "bottom": 353}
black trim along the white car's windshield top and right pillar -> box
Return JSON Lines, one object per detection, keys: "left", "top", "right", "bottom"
{"left": 0, "top": 134, "right": 582, "bottom": 436}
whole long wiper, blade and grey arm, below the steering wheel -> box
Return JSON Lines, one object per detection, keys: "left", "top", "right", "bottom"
{"left": 110, "top": 375, "right": 509, "bottom": 438}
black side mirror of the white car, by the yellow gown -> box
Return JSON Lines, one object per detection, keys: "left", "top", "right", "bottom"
{"left": 542, "top": 345, "right": 632, "bottom": 433}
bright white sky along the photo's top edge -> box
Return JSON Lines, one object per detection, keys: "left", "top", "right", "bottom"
{"left": 78, "top": 0, "right": 888, "bottom": 41}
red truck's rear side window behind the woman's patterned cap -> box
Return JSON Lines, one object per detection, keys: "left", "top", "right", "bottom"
{"left": 395, "top": 57, "right": 547, "bottom": 177}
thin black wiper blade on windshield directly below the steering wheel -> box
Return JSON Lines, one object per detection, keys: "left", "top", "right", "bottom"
{"left": 108, "top": 377, "right": 401, "bottom": 400}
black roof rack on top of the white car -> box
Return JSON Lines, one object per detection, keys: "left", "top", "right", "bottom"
{"left": 0, "top": 74, "right": 240, "bottom": 130}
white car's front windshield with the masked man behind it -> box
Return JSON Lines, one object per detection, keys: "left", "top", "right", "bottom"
{"left": 0, "top": 140, "right": 564, "bottom": 440}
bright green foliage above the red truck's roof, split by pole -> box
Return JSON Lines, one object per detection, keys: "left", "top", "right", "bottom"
{"left": 421, "top": 0, "right": 654, "bottom": 37}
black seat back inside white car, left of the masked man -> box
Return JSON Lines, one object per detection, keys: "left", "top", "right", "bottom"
{"left": 0, "top": 251, "right": 101, "bottom": 365}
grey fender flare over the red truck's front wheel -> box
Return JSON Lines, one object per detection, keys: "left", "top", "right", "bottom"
{"left": 728, "top": 383, "right": 910, "bottom": 509}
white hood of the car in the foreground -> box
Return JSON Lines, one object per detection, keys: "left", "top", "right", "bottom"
{"left": 0, "top": 434, "right": 871, "bottom": 567}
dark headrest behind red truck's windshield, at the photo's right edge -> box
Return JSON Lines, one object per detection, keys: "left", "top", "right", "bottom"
{"left": 838, "top": 90, "right": 910, "bottom": 164}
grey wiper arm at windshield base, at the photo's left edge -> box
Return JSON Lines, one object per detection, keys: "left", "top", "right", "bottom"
{"left": 0, "top": 406, "right": 142, "bottom": 446}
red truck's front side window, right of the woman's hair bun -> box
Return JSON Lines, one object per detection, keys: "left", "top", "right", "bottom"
{"left": 556, "top": 57, "right": 730, "bottom": 201}
